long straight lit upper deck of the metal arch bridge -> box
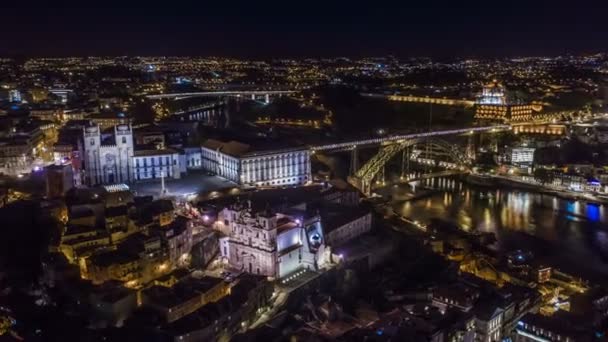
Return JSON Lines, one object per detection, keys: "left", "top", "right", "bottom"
{"left": 310, "top": 125, "right": 511, "bottom": 152}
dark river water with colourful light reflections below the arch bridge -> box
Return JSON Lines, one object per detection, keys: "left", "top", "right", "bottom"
{"left": 393, "top": 178, "right": 608, "bottom": 284}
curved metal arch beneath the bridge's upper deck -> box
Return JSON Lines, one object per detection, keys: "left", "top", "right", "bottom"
{"left": 349, "top": 138, "right": 470, "bottom": 195}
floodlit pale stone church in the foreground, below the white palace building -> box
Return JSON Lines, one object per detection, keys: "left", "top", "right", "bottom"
{"left": 216, "top": 204, "right": 329, "bottom": 278}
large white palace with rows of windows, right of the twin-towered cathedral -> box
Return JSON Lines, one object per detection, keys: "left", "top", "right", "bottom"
{"left": 201, "top": 139, "right": 311, "bottom": 186}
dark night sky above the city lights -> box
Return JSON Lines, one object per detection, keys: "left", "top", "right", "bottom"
{"left": 0, "top": 0, "right": 608, "bottom": 58}
